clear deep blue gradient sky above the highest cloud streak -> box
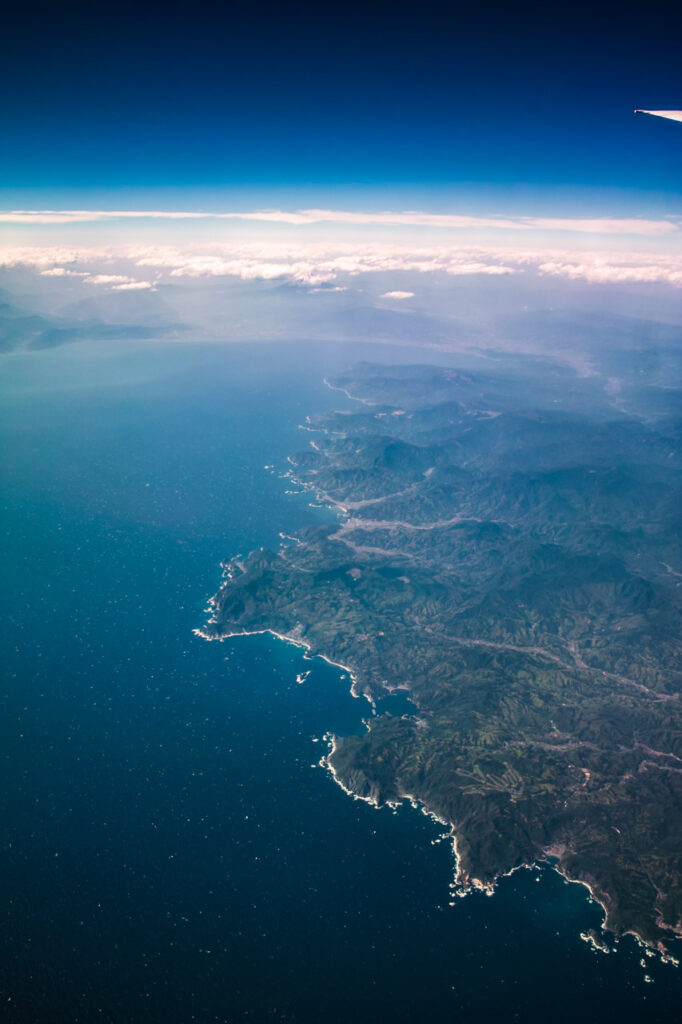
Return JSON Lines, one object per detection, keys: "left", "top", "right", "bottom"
{"left": 0, "top": 2, "right": 682, "bottom": 208}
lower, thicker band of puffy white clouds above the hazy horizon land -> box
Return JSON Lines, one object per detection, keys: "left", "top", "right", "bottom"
{"left": 0, "top": 244, "right": 682, "bottom": 288}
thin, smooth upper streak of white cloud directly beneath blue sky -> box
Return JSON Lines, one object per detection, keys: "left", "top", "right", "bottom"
{"left": 0, "top": 209, "right": 680, "bottom": 237}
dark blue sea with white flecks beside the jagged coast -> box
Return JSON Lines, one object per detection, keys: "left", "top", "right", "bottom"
{"left": 0, "top": 346, "right": 680, "bottom": 1024}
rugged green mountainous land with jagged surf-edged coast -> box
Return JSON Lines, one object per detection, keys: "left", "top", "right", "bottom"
{"left": 196, "top": 360, "right": 682, "bottom": 951}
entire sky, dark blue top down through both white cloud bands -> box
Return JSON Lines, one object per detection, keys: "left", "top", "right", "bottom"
{"left": 0, "top": 0, "right": 682, "bottom": 303}
